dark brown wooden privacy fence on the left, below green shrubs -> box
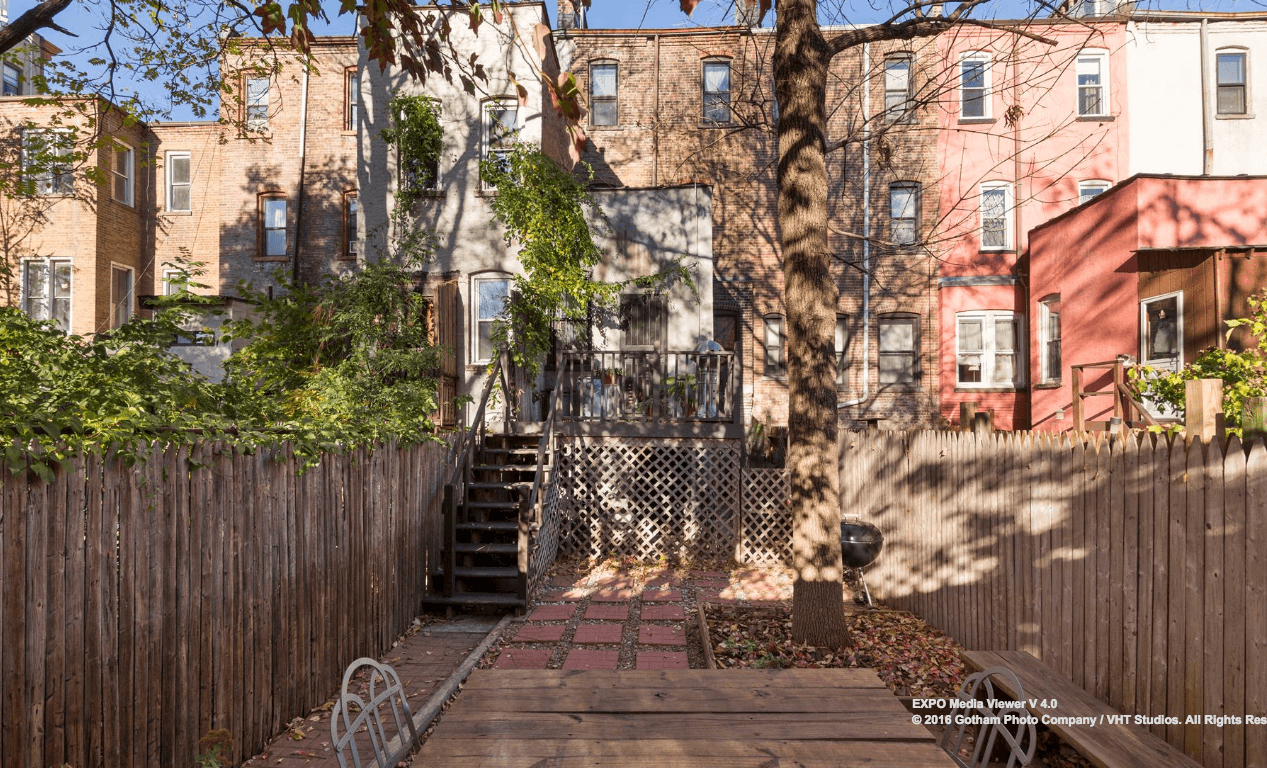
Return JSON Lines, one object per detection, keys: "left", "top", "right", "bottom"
{"left": 0, "top": 445, "right": 456, "bottom": 768}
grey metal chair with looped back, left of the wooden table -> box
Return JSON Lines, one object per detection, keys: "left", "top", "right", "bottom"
{"left": 329, "top": 658, "right": 418, "bottom": 768}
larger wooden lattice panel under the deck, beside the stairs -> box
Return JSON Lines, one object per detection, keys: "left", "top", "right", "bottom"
{"left": 559, "top": 437, "right": 740, "bottom": 559}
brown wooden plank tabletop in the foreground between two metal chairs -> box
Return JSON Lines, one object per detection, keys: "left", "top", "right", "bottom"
{"left": 413, "top": 669, "right": 954, "bottom": 768}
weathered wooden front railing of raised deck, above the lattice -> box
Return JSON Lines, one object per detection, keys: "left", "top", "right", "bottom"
{"left": 559, "top": 351, "right": 740, "bottom": 423}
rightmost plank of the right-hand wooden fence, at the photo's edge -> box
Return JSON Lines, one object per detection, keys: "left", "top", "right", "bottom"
{"left": 1244, "top": 441, "right": 1267, "bottom": 768}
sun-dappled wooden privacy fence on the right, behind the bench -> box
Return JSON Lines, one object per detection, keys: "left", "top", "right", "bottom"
{"left": 840, "top": 432, "right": 1267, "bottom": 768}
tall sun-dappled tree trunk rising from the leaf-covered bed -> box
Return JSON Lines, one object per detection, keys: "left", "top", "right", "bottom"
{"left": 774, "top": 0, "right": 848, "bottom": 648}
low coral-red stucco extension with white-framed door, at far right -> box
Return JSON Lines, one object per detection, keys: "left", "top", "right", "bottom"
{"left": 1025, "top": 174, "right": 1267, "bottom": 431}
